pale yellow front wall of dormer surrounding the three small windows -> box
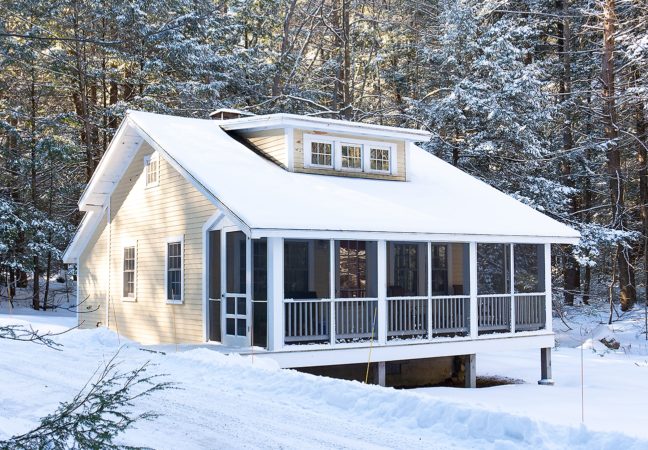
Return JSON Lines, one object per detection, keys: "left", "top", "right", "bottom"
{"left": 293, "top": 129, "right": 407, "bottom": 181}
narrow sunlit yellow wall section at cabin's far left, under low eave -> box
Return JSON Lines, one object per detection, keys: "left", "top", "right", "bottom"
{"left": 78, "top": 213, "right": 108, "bottom": 328}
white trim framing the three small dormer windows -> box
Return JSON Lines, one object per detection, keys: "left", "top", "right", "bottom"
{"left": 304, "top": 134, "right": 398, "bottom": 175}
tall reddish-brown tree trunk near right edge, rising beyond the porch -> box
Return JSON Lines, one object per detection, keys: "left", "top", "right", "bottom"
{"left": 601, "top": 0, "right": 637, "bottom": 311}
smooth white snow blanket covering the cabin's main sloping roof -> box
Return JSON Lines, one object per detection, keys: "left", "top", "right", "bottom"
{"left": 128, "top": 111, "right": 579, "bottom": 238}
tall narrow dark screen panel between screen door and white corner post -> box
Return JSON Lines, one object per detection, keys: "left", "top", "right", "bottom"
{"left": 252, "top": 238, "right": 268, "bottom": 347}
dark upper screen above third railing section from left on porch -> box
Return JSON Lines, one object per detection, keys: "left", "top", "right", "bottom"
{"left": 387, "top": 242, "right": 427, "bottom": 297}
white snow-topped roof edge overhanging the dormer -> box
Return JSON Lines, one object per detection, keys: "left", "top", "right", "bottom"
{"left": 219, "top": 114, "right": 432, "bottom": 142}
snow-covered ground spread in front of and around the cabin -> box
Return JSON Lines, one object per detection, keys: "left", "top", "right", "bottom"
{"left": 0, "top": 302, "right": 648, "bottom": 449}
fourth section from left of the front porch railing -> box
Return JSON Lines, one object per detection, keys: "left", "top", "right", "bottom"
{"left": 432, "top": 295, "right": 470, "bottom": 336}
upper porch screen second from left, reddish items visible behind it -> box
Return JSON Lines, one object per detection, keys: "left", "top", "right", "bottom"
{"left": 336, "top": 241, "right": 378, "bottom": 298}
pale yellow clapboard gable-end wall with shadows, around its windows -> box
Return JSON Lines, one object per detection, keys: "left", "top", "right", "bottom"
{"left": 80, "top": 143, "right": 216, "bottom": 344}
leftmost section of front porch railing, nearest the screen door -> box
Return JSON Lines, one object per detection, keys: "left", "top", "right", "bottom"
{"left": 284, "top": 299, "right": 331, "bottom": 344}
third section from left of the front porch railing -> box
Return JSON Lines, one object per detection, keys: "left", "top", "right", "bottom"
{"left": 387, "top": 297, "right": 428, "bottom": 340}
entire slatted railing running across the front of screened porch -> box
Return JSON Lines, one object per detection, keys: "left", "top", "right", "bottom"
{"left": 284, "top": 293, "right": 546, "bottom": 344}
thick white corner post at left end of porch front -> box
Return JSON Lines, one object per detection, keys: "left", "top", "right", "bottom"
{"left": 268, "top": 237, "right": 284, "bottom": 351}
